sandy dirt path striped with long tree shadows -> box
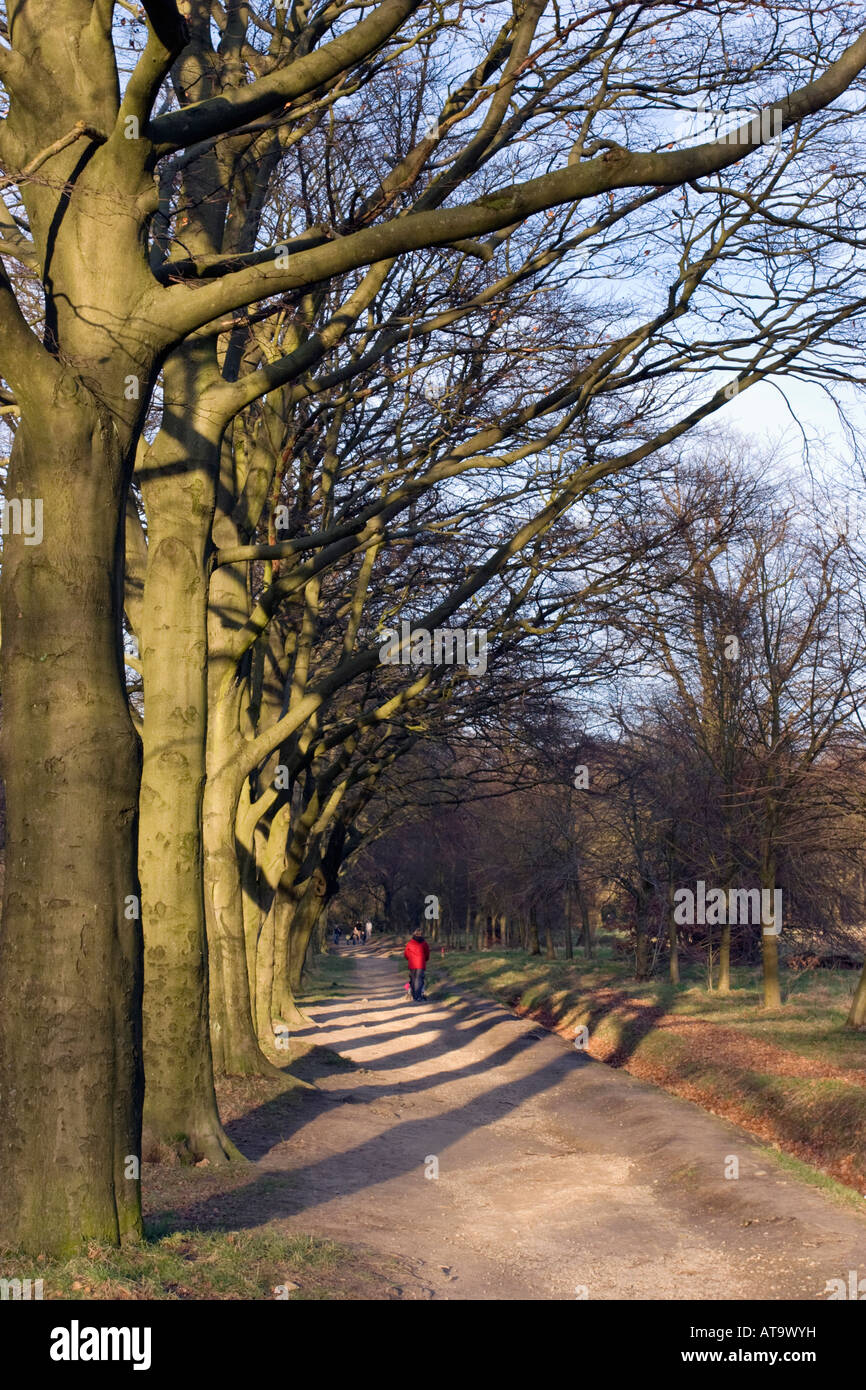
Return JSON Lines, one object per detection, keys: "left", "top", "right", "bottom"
{"left": 219, "top": 948, "right": 866, "bottom": 1300}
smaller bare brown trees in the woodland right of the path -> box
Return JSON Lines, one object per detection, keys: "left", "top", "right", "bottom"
{"left": 339, "top": 448, "right": 866, "bottom": 1027}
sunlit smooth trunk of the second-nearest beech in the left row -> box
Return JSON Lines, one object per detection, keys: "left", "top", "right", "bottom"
{"left": 139, "top": 400, "right": 238, "bottom": 1163}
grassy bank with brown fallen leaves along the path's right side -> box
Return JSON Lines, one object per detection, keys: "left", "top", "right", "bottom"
{"left": 431, "top": 942, "right": 866, "bottom": 1193}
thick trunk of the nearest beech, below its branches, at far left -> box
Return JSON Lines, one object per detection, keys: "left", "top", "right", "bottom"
{"left": 0, "top": 405, "right": 143, "bottom": 1257}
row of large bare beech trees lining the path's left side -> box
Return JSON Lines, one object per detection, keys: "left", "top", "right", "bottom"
{"left": 0, "top": 0, "right": 866, "bottom": 1251}
